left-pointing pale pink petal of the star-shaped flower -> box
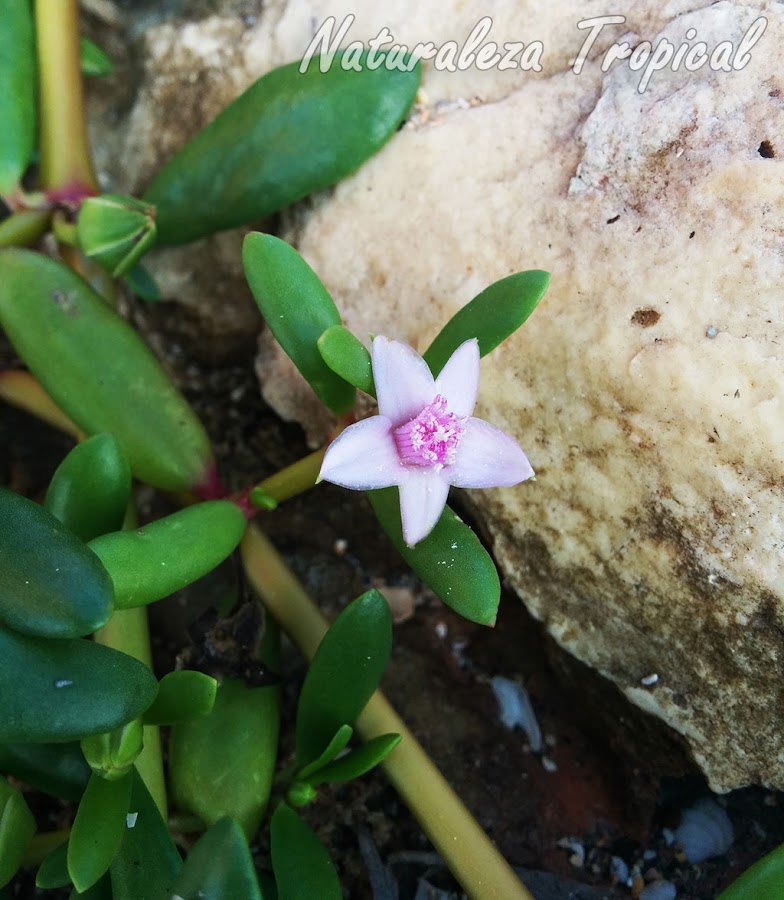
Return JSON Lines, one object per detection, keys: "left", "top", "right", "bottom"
{"left": 319, "top": 416, "right": 405, "bottom": 491}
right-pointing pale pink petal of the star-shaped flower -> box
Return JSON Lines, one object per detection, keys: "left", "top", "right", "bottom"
{"left": 441, "top": 417, "right": 534, "bottom": 487}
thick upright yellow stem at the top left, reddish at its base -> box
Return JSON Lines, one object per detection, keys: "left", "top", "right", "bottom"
{"left": 35, "top": 0, "right": 97, "bottom": 189}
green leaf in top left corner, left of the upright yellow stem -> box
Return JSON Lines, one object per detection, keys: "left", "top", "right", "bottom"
{"left": 0, "top": 0, "right": 36, "bottom": 194}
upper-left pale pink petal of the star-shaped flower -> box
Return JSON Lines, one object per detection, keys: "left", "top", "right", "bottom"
{"left": 371, "top": 335, "right": 436, "bottom": 428}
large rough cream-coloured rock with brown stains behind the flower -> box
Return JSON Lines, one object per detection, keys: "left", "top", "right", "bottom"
{"left": 89, "top": 0, "right": 784, "bottom": 790}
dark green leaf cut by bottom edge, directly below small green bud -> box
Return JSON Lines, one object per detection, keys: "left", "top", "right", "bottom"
{"left": 270, "top": 803, "right": 343, "bottom": 900}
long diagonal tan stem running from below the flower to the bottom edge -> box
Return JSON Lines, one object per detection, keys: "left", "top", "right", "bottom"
{"left": 242, "top": 525, "right": 533, "bottom": 900}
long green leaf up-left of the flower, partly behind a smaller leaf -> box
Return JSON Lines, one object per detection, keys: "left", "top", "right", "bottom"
{"left": 242, "top": 232, "right": 356, "bottom": 413}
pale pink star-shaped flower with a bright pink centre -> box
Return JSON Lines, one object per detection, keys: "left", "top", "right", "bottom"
{"left": 319, "top": 337, "right": 534, "bottom": 547}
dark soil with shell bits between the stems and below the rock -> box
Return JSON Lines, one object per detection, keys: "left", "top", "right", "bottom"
{"left": 0, "top": 303, "right": 784, "bottom": 900}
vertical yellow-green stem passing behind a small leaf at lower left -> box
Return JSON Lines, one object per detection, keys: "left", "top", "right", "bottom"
{"left": 95, "top": 606, "right": 168, "bottom": 821}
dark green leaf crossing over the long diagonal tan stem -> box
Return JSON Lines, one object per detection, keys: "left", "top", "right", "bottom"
{"left": 296, "top": 590, "right": 392, "bottom": 768}
